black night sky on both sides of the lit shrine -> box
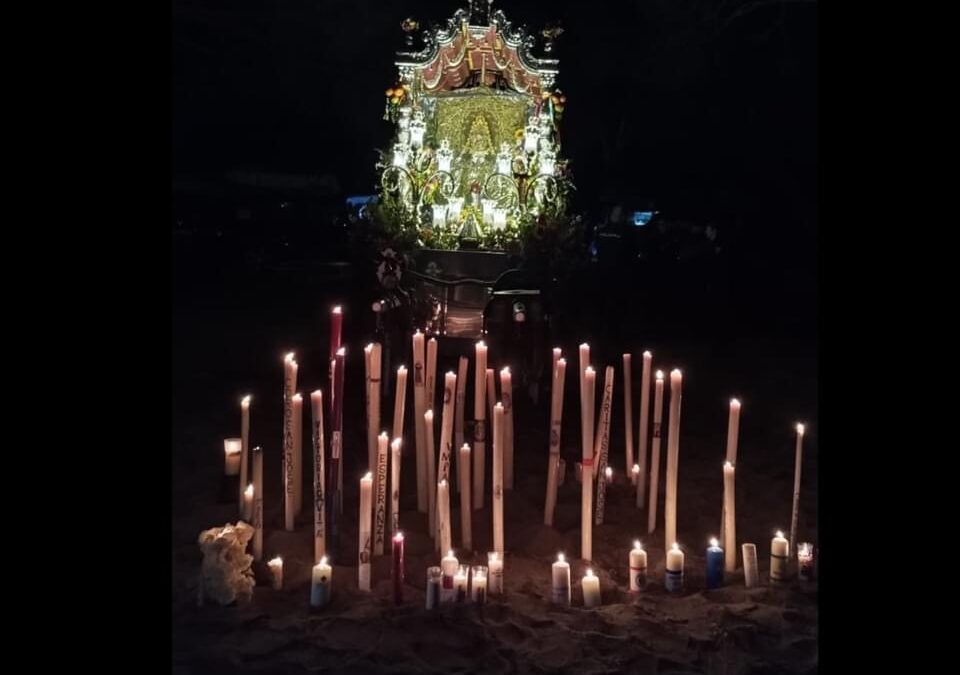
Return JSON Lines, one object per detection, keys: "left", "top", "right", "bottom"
{"left": 173, "top": 0, "right": 817, "bottom": 223}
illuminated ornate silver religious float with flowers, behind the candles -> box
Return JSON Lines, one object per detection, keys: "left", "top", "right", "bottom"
{"left": 370, "top": 1, "right": 581, "bottom": 396}
